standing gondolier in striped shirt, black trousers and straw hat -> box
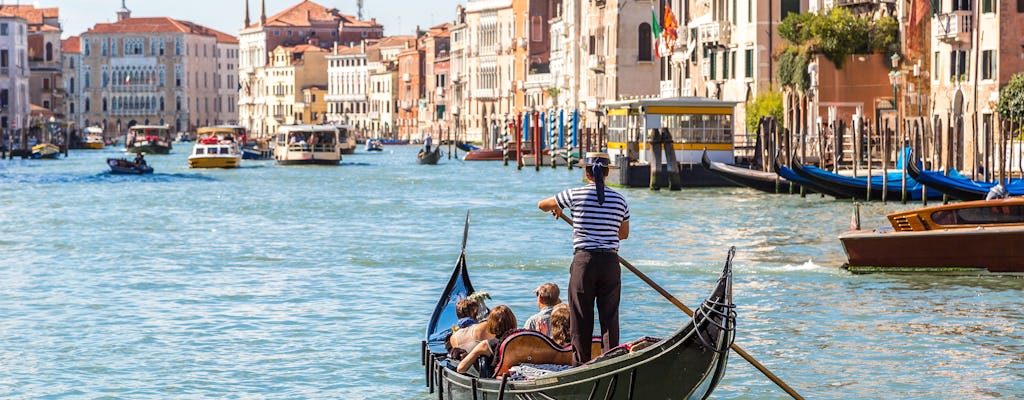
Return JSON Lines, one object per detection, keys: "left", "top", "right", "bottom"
{"left": 537, "top": 152, "right": 630, "bottom": 364}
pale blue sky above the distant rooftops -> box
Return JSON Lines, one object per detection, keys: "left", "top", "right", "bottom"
{"left": 47, "top": 0, "right": 466, "bottom": 38}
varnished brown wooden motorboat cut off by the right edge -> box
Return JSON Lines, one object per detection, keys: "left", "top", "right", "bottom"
{"left": 839, "top": 197, "right": 1024, "bottom": 273}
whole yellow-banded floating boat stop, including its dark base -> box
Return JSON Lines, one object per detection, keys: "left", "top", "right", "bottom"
{"left": 602, "top": 97, "right": 736, "bottom": 187}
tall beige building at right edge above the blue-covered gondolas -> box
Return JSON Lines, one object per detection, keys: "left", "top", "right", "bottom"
{"left": 929, "top": 0, "right": 1024, "bottom": 173}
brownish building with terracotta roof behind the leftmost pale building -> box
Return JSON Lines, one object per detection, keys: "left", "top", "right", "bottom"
{"left": 0, "top": 5, "right": 65, "bottom": 120}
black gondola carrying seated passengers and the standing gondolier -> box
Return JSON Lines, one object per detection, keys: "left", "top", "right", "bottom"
{"left": 422, "top": 217, "right": 735, "bottom": 400}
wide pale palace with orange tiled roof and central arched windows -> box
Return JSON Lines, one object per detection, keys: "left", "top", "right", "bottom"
{"left": 79, "top": 2, "right": 238, "bottom": 134}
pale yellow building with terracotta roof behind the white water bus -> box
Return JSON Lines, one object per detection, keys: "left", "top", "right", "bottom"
{"left": 263, "top": 43, "right": 328, "bottom": 132}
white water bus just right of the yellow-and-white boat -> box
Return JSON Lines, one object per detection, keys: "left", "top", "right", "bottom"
{"left": 273, "top": 125, "right": 342, "bottom": 166}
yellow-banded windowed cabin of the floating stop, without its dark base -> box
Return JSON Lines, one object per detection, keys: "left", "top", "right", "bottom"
{"left": 602, "top": 97, "right": 736, "bottom": 167}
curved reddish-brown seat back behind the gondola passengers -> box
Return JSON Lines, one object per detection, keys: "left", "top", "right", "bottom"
{"left": 494, "top": 329, "right": 572, "bottom": 377}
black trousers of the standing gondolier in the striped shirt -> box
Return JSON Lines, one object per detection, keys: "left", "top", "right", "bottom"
{"left": 568, "top": 251, "right": 623, "bottom": 364}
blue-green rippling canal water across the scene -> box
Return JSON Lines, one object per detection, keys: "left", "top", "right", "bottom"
{"left": 0, "top": 144, "right": 1024, "bottom": 399}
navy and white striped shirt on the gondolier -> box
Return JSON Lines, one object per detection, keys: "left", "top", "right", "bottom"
{"left": 555, "top": 183, "right": 630, "bottom": 251}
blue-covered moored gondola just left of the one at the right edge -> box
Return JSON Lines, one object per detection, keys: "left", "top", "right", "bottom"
{"left": 793, "top": 159, "right": 942, "bottom": 201}
